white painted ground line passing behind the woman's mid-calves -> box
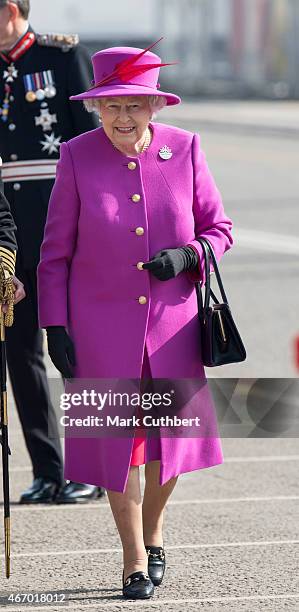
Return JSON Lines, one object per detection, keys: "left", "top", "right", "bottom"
{"left": 7, "top": 495, "right": 299, "bottom": 513}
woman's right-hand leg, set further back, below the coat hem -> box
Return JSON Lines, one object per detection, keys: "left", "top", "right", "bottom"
{"left": 142, "top": 461, "right": 178, "bottom": 546}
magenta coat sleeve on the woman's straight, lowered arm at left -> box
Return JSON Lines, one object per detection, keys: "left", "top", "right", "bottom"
{"left": 38, "top": 143, "right": 80, "bottom": 327}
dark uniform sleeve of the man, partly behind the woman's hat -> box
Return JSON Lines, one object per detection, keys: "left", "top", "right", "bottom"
{"left": 67, "top": 45, "right": 99, "bottom": 136}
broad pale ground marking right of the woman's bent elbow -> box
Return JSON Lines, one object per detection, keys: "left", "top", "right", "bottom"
{"left": 234, "top": 227, "right": 299, "bottom": 255}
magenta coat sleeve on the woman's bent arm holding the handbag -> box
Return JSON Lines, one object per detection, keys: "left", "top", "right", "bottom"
{"left": 187, "top": 134, "right": 233, "bottom": 282}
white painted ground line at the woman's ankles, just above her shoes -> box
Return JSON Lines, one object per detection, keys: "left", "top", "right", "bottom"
{"left": 1, "top": 540, "right": 299, "bottom": 559}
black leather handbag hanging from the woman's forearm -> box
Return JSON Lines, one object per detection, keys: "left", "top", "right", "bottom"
{"left": 195, "top": 238, "right": 246, "bottom": 367}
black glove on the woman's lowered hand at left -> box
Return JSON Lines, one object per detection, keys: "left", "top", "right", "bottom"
{"left": 47, "top": 326, "right": 76, "bottom": 378}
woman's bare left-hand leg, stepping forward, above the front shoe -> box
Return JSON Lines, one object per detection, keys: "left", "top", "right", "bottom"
{"left": 107, "top": 466, "right": 148, "bottom": 579}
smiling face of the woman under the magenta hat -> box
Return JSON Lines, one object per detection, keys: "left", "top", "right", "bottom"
{"left": 100, "top": 96, "right": 152, "bottom": 151}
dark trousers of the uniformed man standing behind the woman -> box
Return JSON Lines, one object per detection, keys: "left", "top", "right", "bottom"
{"left": 6, "top": 265, "right": 64, "bottom": 484}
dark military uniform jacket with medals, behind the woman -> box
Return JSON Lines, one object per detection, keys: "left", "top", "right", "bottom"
{"left": 0, "top": 28, "right": 98, "bottom": 269}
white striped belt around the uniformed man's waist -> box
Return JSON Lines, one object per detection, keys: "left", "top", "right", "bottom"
{"left": 2, "top": 159, "right": 58, "bottom": 183}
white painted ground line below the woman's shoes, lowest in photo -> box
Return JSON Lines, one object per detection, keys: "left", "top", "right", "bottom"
{"left": 0, "top": 593, "right": 299, "bottom": 612}
